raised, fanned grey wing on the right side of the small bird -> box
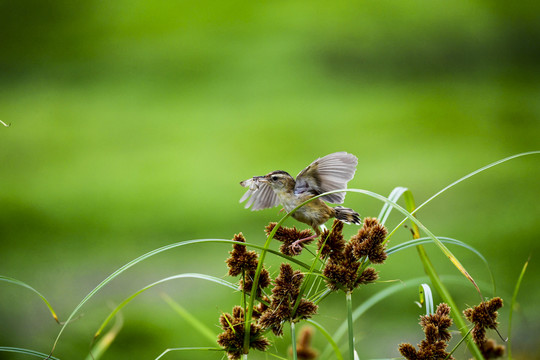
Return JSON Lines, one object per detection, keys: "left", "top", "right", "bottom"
{"left": 294, "top": 152, "right": 358, "bottom": 204}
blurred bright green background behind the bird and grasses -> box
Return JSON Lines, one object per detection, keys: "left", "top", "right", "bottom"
{"left": 0, "top": 0, "right": 540, "bottom": 359}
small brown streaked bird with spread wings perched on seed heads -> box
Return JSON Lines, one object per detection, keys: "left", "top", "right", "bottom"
{"left": 240, "top": 152, "right": 361, "bottom": 247}
